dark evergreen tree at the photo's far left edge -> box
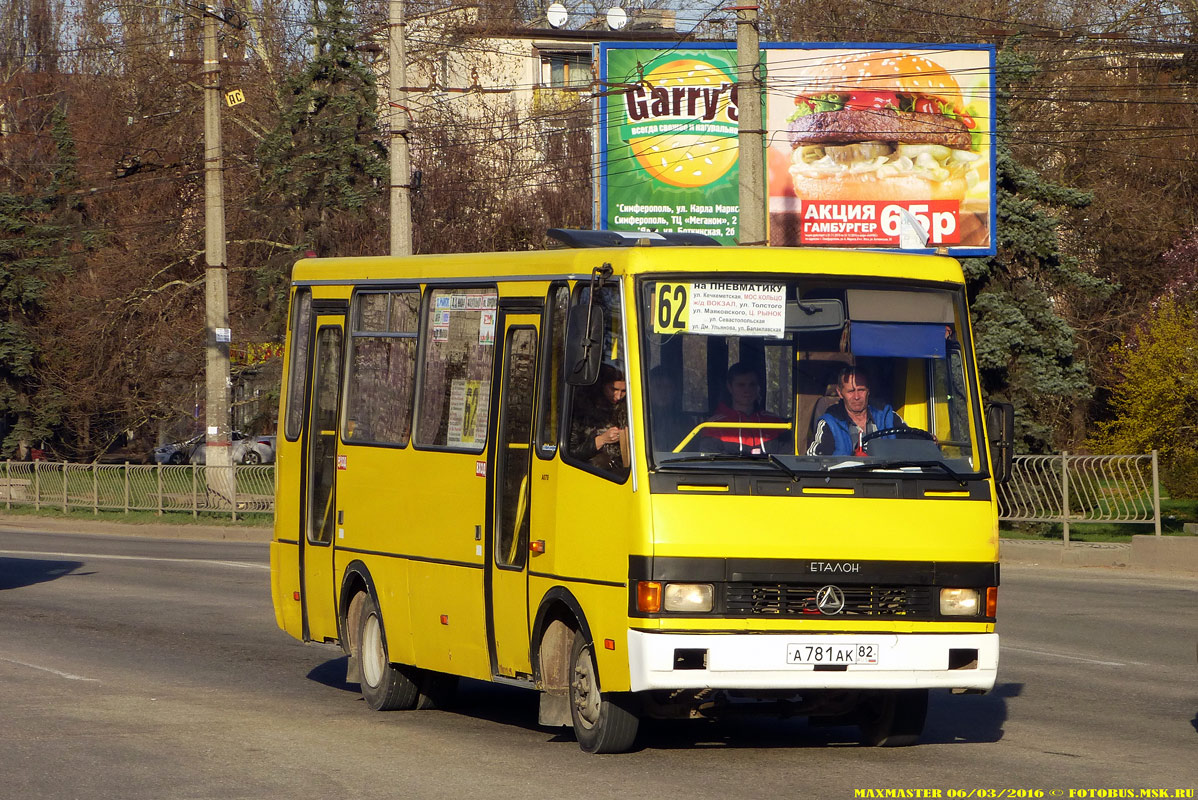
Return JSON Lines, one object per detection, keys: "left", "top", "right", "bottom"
{"left": 0, "top": 107, "right": 85, "bottom": 457}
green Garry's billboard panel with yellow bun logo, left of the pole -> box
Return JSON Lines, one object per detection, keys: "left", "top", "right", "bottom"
{"left": 599, "top": 47, "right": 740, "bottom": 244}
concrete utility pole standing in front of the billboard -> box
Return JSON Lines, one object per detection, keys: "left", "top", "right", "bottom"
{"left": 732, "top": 6, "right": 768, "bottom": 247}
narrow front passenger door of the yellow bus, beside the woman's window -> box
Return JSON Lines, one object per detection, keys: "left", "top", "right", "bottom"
{"left": 486, "top": 313, "right": 540, "bottom": 678}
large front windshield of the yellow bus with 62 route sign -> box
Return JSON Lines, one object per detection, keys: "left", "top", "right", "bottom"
{"left": 640, "top": 274, "right": 984, "bottom": 480}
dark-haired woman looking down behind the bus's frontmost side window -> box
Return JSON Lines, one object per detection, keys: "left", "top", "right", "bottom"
{"left": 570, "top": 364, "right": 629, "bottom": 474}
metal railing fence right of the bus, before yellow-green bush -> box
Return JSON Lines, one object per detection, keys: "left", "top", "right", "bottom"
{"left": 998, "top": 450, "right": 1161, "bottom": 541}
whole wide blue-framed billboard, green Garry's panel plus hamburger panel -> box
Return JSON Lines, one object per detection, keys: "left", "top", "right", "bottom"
{"left": 597, "top": 43, "right": 996, "bottom": 255}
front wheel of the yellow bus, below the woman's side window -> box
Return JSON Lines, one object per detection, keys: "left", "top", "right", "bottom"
{"left": 569, "top": 631, "right": 641, "bottom": 753}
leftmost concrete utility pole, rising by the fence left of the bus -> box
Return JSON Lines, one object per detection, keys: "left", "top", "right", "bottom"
{"left": 204, "top": 6, "right": 232, "bottom": 481}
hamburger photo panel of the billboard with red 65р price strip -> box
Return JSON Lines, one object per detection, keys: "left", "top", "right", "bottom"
{"left": 766, "top": 47, "right": 994, "bottom": 255}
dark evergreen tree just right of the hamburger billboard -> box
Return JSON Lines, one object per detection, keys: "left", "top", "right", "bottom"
{"left": 963, "top": 48, "right": 1113, "bottom": 453}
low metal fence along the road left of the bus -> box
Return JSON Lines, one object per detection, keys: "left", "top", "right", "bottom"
{"left": 0, "top": 461, "right": 274, "bottom": 520}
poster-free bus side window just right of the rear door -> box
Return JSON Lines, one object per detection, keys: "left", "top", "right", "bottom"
{"left": 341, "top": 291, "right": 420, "bottom": 447}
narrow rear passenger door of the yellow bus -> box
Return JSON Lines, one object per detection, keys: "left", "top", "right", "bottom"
{"left": 300, "top": 313, "right": 345, "bottom": 642}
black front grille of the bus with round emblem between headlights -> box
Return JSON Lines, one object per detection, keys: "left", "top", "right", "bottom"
{"left": 724, "top": 582, "right": 933, "bottom": 618}
